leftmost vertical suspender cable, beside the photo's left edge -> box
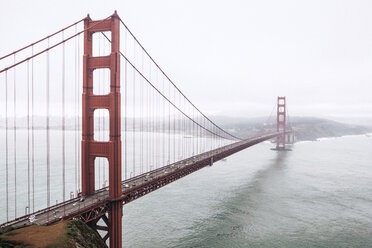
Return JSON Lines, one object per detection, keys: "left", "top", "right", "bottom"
{"left": 5, "top": 71, "right": 9, "bottom": 222}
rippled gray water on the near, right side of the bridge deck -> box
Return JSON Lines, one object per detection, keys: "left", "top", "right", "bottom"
{"left": 123, "top": 135, "right": 372, "bottom": 248}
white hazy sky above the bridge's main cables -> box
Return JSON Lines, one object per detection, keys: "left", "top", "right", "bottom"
{"left": 0, "top": 0, "right": 372, "bottom": 120}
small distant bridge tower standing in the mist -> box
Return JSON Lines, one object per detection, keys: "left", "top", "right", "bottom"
{"left": 276, "top": 96, "right": 286, "bottom": 150}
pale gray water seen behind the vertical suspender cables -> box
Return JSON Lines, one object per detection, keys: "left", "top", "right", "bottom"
{"left": 0, "top": 129, "right": 232, "bottom": 224}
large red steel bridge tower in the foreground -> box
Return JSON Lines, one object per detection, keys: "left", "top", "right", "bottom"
{"left": 82, "top": 11, "right": 123, "bottom": 248}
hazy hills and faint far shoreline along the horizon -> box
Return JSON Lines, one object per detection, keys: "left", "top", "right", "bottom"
{"left": 0, "top": 116, "right": 372, "bottom": 141}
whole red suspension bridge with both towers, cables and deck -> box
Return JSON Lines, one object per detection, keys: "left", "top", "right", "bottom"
{"left": 0, "top": 12, "right": 292, "bottom": 247}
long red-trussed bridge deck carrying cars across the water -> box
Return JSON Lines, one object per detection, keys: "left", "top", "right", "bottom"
{"left": 1, "top": 132, "right": 288, "bottom": 230}
